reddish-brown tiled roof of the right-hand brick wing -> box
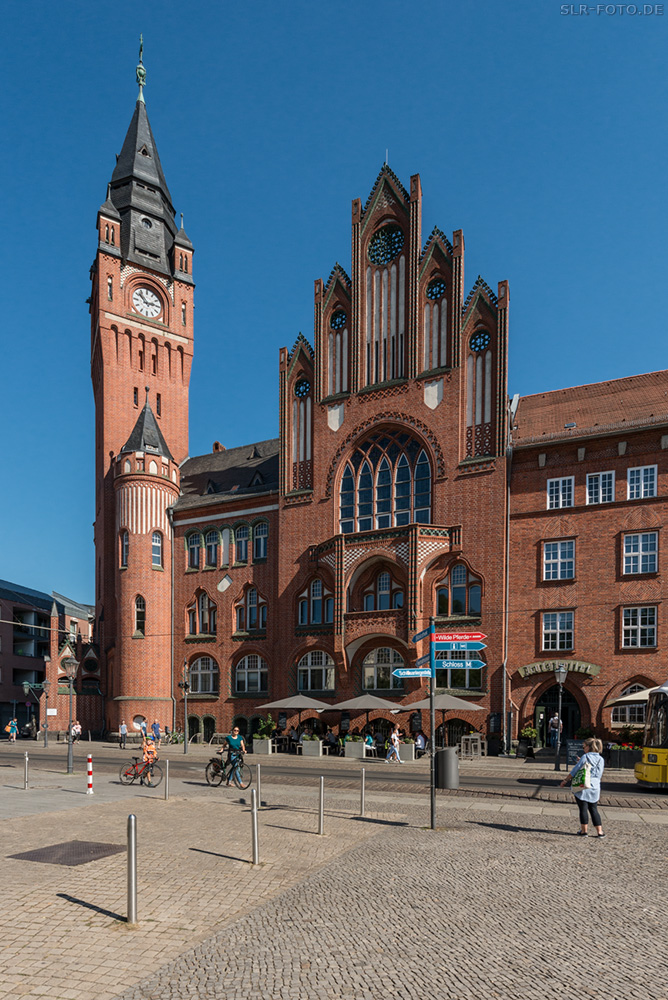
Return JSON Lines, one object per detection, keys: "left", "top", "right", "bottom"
{"left": 513, "top": 371, "right": 668, "bottom": 447}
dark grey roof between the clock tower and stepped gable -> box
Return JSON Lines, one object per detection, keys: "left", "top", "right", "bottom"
{"left": 176, "top": 438, "right": 279, "bottom": 510}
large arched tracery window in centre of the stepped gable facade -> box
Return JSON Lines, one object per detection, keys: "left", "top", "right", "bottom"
{"left": 339, "top": 431, "right": 431, "bottom": 534}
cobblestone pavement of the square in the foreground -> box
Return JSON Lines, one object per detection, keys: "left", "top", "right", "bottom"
{"left": 0, "top": 761, "right": 668, "bottom": 1000}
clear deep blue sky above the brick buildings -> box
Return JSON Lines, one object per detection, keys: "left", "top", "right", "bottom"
{"left": 0, "top": 0, "right": 668, "bottom": 601}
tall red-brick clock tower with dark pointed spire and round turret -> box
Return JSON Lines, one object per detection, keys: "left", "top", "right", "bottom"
{"left": 90, "top": 41, "right": 194, "bottom": 730}
